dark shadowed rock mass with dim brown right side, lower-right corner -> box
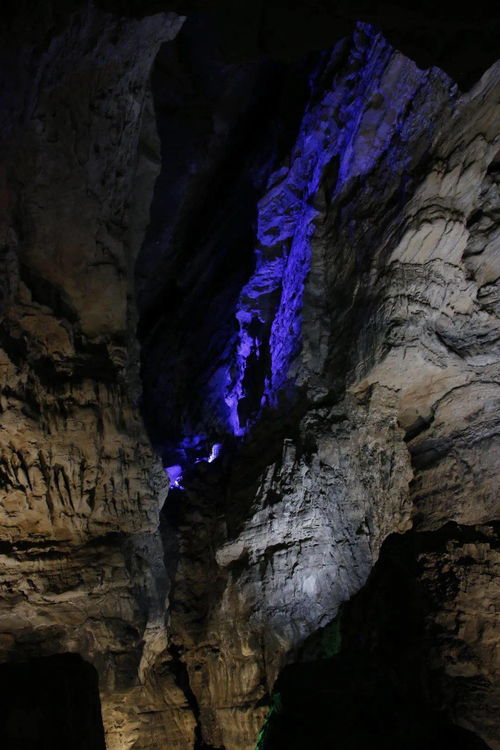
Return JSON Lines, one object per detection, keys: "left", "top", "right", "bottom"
{"left": 260, "top": 523, "right": 498, "bottom": 750}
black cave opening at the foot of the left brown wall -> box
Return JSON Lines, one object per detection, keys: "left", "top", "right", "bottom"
{"left": 0, "top": 654, "right": 106, "bottom": 750}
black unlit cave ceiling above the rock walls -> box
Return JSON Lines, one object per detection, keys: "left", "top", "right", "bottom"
{"left": 2, "top": 0, "right": 500, "bottom": 89}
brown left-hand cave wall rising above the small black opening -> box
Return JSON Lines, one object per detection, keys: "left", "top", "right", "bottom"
{"left": 0, "top": 5, "right": 188, "bottom": 750}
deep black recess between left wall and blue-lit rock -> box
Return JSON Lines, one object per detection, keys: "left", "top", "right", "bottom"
{"left": 135, "top": 15, "right": 312, "bottom": 465}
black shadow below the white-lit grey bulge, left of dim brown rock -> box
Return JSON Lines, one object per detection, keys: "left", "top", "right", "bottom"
{"left": 258, "top": 524, "right": 487, "bottom": 750}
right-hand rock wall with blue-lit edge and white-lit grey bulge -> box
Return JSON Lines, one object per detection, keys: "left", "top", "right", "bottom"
{"left": 143, "top": 26, "right": 499, "bottom": 748}
